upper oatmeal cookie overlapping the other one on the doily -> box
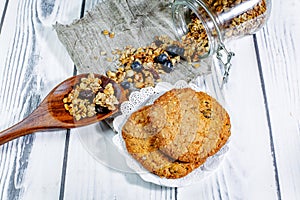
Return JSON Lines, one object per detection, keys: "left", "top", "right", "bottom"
{"left": 155, "top": 88, "right": 230, "bottom": 162}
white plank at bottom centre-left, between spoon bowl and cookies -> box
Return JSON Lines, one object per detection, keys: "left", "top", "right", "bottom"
{"left": 64, "top": 124, "right": 176, "bottom": 200}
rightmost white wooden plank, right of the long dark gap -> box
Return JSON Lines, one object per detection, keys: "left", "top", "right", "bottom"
{"left": 257, "top": 0, "right": 300, "bottom": 199}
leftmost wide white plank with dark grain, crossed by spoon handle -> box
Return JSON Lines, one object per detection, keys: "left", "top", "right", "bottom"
{"left": 0, "top": 0, "right": 81, "bottom": 199}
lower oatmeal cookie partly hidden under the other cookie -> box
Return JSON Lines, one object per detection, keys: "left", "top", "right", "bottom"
{"left": 122, "top": 106, "right": 204, "bottom": 178}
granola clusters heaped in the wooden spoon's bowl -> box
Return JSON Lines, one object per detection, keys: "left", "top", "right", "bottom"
{"left": 63, "top": 74, "right": 119, "bottom": 120}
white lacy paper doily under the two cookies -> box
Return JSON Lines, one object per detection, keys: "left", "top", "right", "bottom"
{"left": 113, "top": 80, "right": 229, "bottom": 187}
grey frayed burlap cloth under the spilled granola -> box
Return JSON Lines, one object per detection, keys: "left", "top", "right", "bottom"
{"left": 54, "top": 0, "right": 212, "bottom": 83}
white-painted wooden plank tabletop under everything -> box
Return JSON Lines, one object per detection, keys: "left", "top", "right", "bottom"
{"left": 0, "top": 0, "right": 300, "bottom": 200}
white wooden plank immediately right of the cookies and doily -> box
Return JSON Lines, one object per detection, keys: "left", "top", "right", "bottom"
{"left": 178, "top": 37, "right": 277, "bottom": 199}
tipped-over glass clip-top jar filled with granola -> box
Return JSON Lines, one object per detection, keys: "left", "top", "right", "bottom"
{"left": 172, "top": 0, "right": 271, "bottom": 80}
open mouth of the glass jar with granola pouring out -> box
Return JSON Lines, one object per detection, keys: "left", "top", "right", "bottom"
{"left": 172, "top": 1, "right": 220, "bottom": 61}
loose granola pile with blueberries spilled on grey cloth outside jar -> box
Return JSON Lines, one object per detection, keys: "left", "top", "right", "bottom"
{"left": 103, "top": 35, "right": 200, "bottom": 93}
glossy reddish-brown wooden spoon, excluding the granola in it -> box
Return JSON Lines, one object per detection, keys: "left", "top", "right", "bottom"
{"left": 0, "top": 74, "right": 126, "bottom": 145}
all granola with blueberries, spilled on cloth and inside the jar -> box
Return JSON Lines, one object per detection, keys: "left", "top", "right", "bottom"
{"left": 102, "top": 0, "right": 267, "bottom": 93}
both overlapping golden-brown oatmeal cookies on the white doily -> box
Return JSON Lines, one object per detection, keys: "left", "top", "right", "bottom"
{"left": 122, "top": 88, "right": 230, "bottom": 179}
